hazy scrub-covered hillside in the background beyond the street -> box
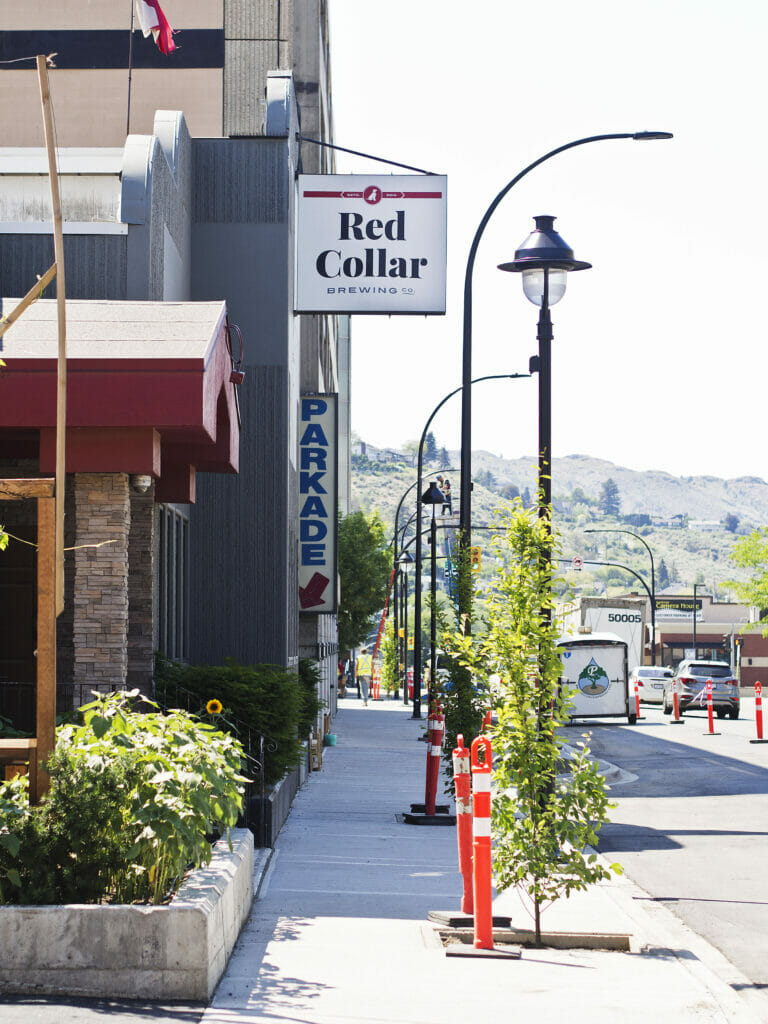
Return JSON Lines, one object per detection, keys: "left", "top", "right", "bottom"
{"left": 352, "top": 445, "right": 768, "bottom": 600}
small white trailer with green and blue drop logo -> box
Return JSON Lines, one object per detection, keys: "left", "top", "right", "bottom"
{"left": 558, "top": 633, "right": 637, "bottom": 725}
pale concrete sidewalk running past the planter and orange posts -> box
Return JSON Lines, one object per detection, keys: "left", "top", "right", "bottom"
{"left": 202, "top": 698, "right": 768, "bottom": 1024}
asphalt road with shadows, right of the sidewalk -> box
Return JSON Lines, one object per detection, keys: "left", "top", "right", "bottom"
{"left": 567, "top": 699, "right": 768, "bottom": 1005}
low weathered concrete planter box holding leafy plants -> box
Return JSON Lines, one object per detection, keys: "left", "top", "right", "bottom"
{"left": 0, "top": 828, "right": 254, "bottom": 1002}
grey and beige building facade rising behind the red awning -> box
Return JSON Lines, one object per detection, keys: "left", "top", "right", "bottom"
{"left": 0, "top": 0, "right": 349, "bottom": 709}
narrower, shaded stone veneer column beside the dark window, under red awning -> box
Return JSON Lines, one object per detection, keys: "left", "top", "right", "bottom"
{"left": 126, "top": 481, "right": 156, "bottom": 694}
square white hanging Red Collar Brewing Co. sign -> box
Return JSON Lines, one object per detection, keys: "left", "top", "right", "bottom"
{"left": 294, "top": 174, "right": 446, "bottom": 314}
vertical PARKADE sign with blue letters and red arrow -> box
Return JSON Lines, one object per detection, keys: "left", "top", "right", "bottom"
{"left": 299, "top": 394, "right": 338, "bottom": 613}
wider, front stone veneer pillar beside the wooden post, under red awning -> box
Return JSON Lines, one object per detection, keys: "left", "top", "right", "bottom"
{"left": 73, "top": 473, "right": 131, "bottom": 690}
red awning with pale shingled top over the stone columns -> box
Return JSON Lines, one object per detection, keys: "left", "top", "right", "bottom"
{"left": 0, "top": 299, "right": 240, "bottom": 502}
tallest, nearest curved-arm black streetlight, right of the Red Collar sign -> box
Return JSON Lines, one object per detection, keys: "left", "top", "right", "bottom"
{"left": 459, "top": 131, "right": 673, "bottom": 614}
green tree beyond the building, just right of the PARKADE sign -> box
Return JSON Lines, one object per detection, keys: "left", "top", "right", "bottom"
{"left": 339, "top": 511, "right": 391, "bottom": 650}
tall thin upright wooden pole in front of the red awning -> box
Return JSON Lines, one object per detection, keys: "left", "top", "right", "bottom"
{"left": 37, "top": 56, "right": 67, "bottom": 614}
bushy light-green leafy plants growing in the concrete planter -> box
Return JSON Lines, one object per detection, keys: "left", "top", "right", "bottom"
{"left": 0, "top": 690, "right": 247, "bottom": 904}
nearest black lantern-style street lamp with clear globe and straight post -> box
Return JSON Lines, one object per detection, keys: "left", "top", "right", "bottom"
{"left": 499, "top": 216, "right": 592, "bottom": 544}
